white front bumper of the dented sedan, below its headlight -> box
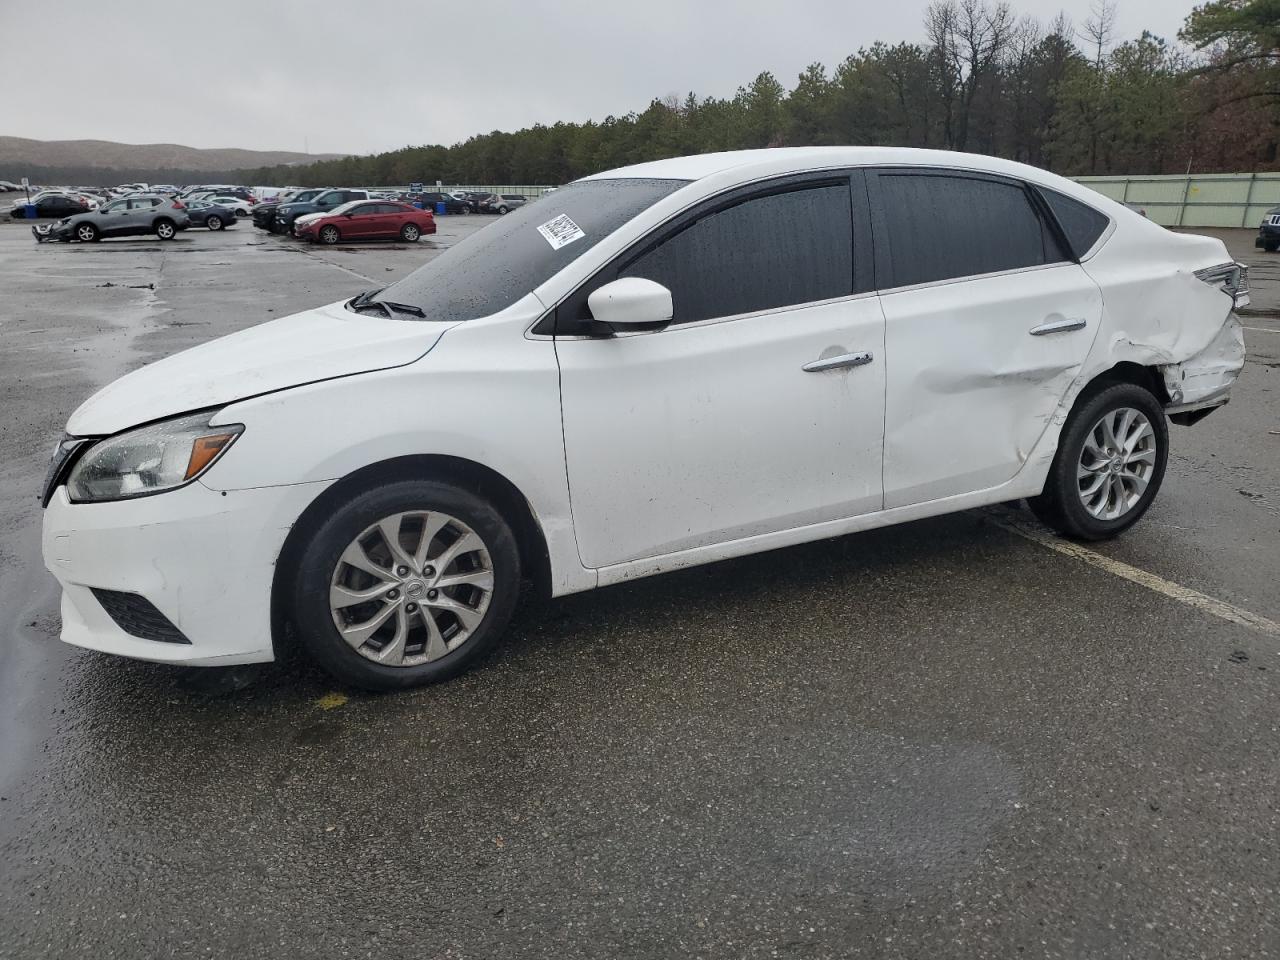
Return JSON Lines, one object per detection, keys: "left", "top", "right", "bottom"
{"left": 42, "top": 481, "right": 329, "bottom": 666}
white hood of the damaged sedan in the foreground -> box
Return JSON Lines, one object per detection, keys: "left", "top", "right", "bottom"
{"left": 67, "top": 301, "right": 453, "bottom": 436}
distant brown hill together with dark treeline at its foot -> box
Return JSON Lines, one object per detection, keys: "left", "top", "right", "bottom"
{"left": 0, "top": 137, "right": 346, "bottom": 186}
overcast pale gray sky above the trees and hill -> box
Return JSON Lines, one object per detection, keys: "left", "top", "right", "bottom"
{"left": 0, "top": 0, "right": 1194, "bottom": 154}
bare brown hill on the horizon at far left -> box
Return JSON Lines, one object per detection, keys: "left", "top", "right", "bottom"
{"left": 0, "top": 137, "right": 344, "bottom": 172}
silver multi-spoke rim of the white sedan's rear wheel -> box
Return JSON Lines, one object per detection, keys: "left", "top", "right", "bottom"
{"left": 1075, "top": 407, "right": 1157, "bottom": 520}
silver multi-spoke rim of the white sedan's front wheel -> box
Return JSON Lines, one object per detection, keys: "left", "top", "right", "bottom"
{"left": 329, "top": 511, "right": 494, "bottom": 667}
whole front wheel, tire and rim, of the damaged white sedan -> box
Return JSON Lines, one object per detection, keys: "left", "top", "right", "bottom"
{"left": 292, "top": 480, "right": 520, "bottom": 690}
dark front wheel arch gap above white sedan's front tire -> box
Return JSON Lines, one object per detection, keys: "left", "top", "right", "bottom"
{"left": 271, "top": 453, "right": 552, "bottom": 657}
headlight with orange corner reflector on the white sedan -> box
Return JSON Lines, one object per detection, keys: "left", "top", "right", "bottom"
{"left": 67, "top": 411, "right": 244, "bottom": 503}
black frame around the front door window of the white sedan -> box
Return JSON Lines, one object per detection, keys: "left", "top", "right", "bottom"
{"left": 535, "top": 166, "right": 876, "bottom": 339}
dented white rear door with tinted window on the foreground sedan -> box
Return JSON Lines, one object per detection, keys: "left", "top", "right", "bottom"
{"left": 869, "top": 168, "right": 1102, "bottom": 508}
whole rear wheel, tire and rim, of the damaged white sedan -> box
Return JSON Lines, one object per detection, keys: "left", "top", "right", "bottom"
{"left": 1028, "top": 383, "right": 1169, "bottom": 540}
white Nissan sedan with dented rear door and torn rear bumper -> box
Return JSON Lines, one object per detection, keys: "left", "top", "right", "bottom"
{"left": 44, "top": 147, "right": 1247, "bottom": 689}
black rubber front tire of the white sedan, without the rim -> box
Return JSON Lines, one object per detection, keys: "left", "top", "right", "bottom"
{"left": 289, "top": 480, "right": 520, "bottom": 690}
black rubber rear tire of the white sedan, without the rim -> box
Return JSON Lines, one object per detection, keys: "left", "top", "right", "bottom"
{"left": 1027, "top": 383, "right": 1169, "bottom": 540}
